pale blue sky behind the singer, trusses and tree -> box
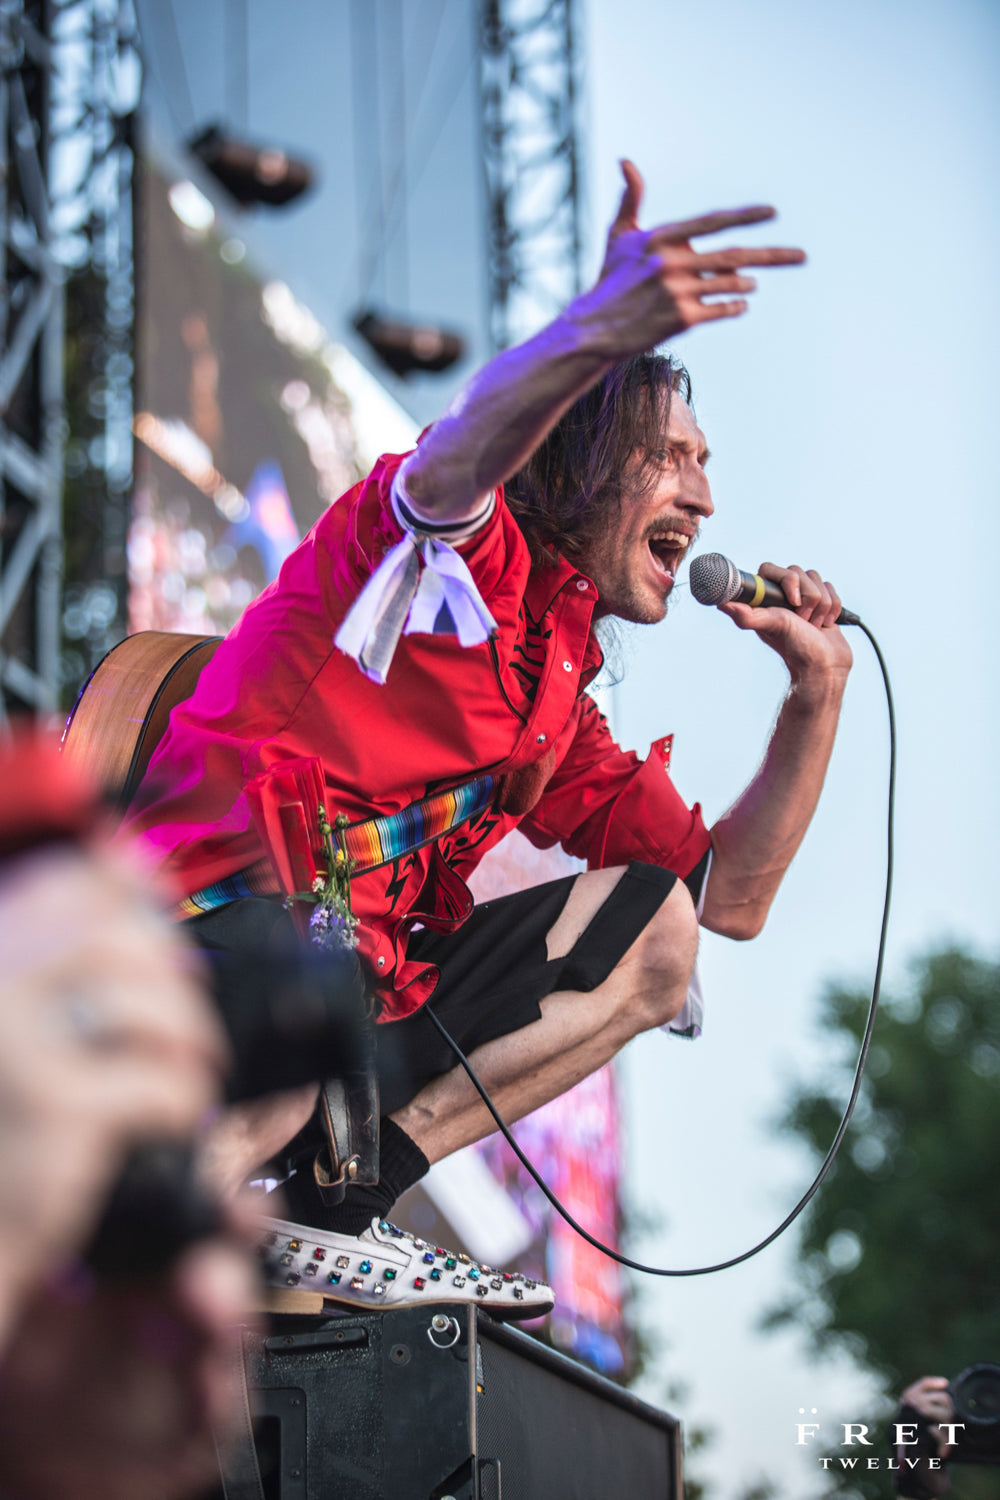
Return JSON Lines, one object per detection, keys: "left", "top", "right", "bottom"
{"left": 142, "top": 0, "right": 1000, "bottom": 1500}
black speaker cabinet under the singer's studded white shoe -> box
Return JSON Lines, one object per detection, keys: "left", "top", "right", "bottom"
{"left": 238, "top": 1305, "right": 682, "bottom": 1500}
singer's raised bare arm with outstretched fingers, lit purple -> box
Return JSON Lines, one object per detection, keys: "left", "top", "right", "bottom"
{"left": 406, "top": 162, "right": 805, "bottom": 522}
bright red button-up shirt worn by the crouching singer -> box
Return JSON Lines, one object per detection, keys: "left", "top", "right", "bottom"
{"left": 127, "top": 456, "right": 709, "bottom": 1020}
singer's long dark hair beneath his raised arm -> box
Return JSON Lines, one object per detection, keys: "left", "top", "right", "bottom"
{"left": 504, "top": 354, "right": 691, "bottom": 563}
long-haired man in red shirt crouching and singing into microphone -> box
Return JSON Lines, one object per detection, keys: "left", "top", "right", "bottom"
{"left": 125, "top": 162, "right": 852, "bottom": 1316}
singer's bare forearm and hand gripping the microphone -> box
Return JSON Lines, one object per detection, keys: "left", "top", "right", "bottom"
{"left": 702, "top": 564, "right": 852, "bottom": 938}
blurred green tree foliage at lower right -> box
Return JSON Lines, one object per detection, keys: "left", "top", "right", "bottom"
{"left": 766, "top": 948, "right": 1000, "bottom": 1500}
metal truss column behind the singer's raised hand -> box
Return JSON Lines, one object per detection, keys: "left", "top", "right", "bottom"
{"left": 480, "top": 0, "right": 582, "bottom": 350}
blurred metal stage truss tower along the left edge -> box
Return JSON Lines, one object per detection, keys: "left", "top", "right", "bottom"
{"left": 0, "top": 0, "right": 139, "bottom": 725}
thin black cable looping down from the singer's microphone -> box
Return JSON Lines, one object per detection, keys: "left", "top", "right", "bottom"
{"left": 424, "top": 620, "right": 897, "bottom": 1277}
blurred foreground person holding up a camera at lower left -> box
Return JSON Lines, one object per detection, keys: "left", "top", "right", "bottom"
{"left": 0, "top": 741, "right": 260, "bottom": 1500}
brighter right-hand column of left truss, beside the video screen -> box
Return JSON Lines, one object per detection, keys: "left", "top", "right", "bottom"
{"left": 52, "top": 0, "right": 142, "bottom": 690}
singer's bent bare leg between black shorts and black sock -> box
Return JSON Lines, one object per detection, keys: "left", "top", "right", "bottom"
{"left": 391, "top": 869, "right": 697, "bottom": 1163}
